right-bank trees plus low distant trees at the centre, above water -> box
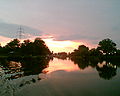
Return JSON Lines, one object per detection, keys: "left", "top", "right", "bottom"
{"left": 54, "top": 38, "right": 120, "bottom": 60}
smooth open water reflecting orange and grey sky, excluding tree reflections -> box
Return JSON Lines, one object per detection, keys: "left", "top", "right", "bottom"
{"left": 15, "top": 59, "right": 120, "bottom": 96}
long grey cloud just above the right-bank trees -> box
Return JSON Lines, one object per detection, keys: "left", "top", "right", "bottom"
{"left": 57, "top": 30, "right": 120, "bottom": 48}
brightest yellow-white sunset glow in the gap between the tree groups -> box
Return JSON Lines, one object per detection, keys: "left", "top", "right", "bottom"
{"left": 43, "top": 38, "right": 83, "bottom": 52}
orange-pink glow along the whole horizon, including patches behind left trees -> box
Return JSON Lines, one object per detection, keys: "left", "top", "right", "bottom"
{"left": 0, "top": 35, "right": 95, "bottom": 53}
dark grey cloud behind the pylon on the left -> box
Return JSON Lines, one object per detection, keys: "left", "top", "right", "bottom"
{"left": 0, "top": 22, "right": 42, "bottom": 38}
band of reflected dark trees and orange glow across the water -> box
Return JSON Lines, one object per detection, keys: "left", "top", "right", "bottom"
{"left": 0, "top": 57, "right": 120, "bottom": 80}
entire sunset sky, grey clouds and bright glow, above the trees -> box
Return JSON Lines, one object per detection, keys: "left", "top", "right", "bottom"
{"left": 0, "top": 0, "right": 120, "bottom": 52}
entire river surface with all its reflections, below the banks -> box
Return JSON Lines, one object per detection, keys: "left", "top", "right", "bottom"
{"left": 0, "top": 58, "right": 120, "bottom": 96}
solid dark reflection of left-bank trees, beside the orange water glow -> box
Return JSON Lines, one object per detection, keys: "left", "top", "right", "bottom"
{"left": 21, "top": 58, "right": 49, "bottom": 76}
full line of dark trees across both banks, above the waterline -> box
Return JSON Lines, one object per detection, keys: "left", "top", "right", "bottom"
{"left": 0, "top": 38, "right": 120, "bottom": 60}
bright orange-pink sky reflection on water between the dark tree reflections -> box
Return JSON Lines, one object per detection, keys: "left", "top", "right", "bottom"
{"left": 43, "top": 58, "right": 94, "bottom": 73}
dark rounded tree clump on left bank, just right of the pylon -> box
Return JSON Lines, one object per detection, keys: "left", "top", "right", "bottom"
{"left": 21, "top": 38, "right": 51, "bottom": 56}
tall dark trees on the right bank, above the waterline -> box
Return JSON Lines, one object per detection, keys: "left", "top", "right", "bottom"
{"left": 69, "top": 38, "right": 120, "bottom": 58}
